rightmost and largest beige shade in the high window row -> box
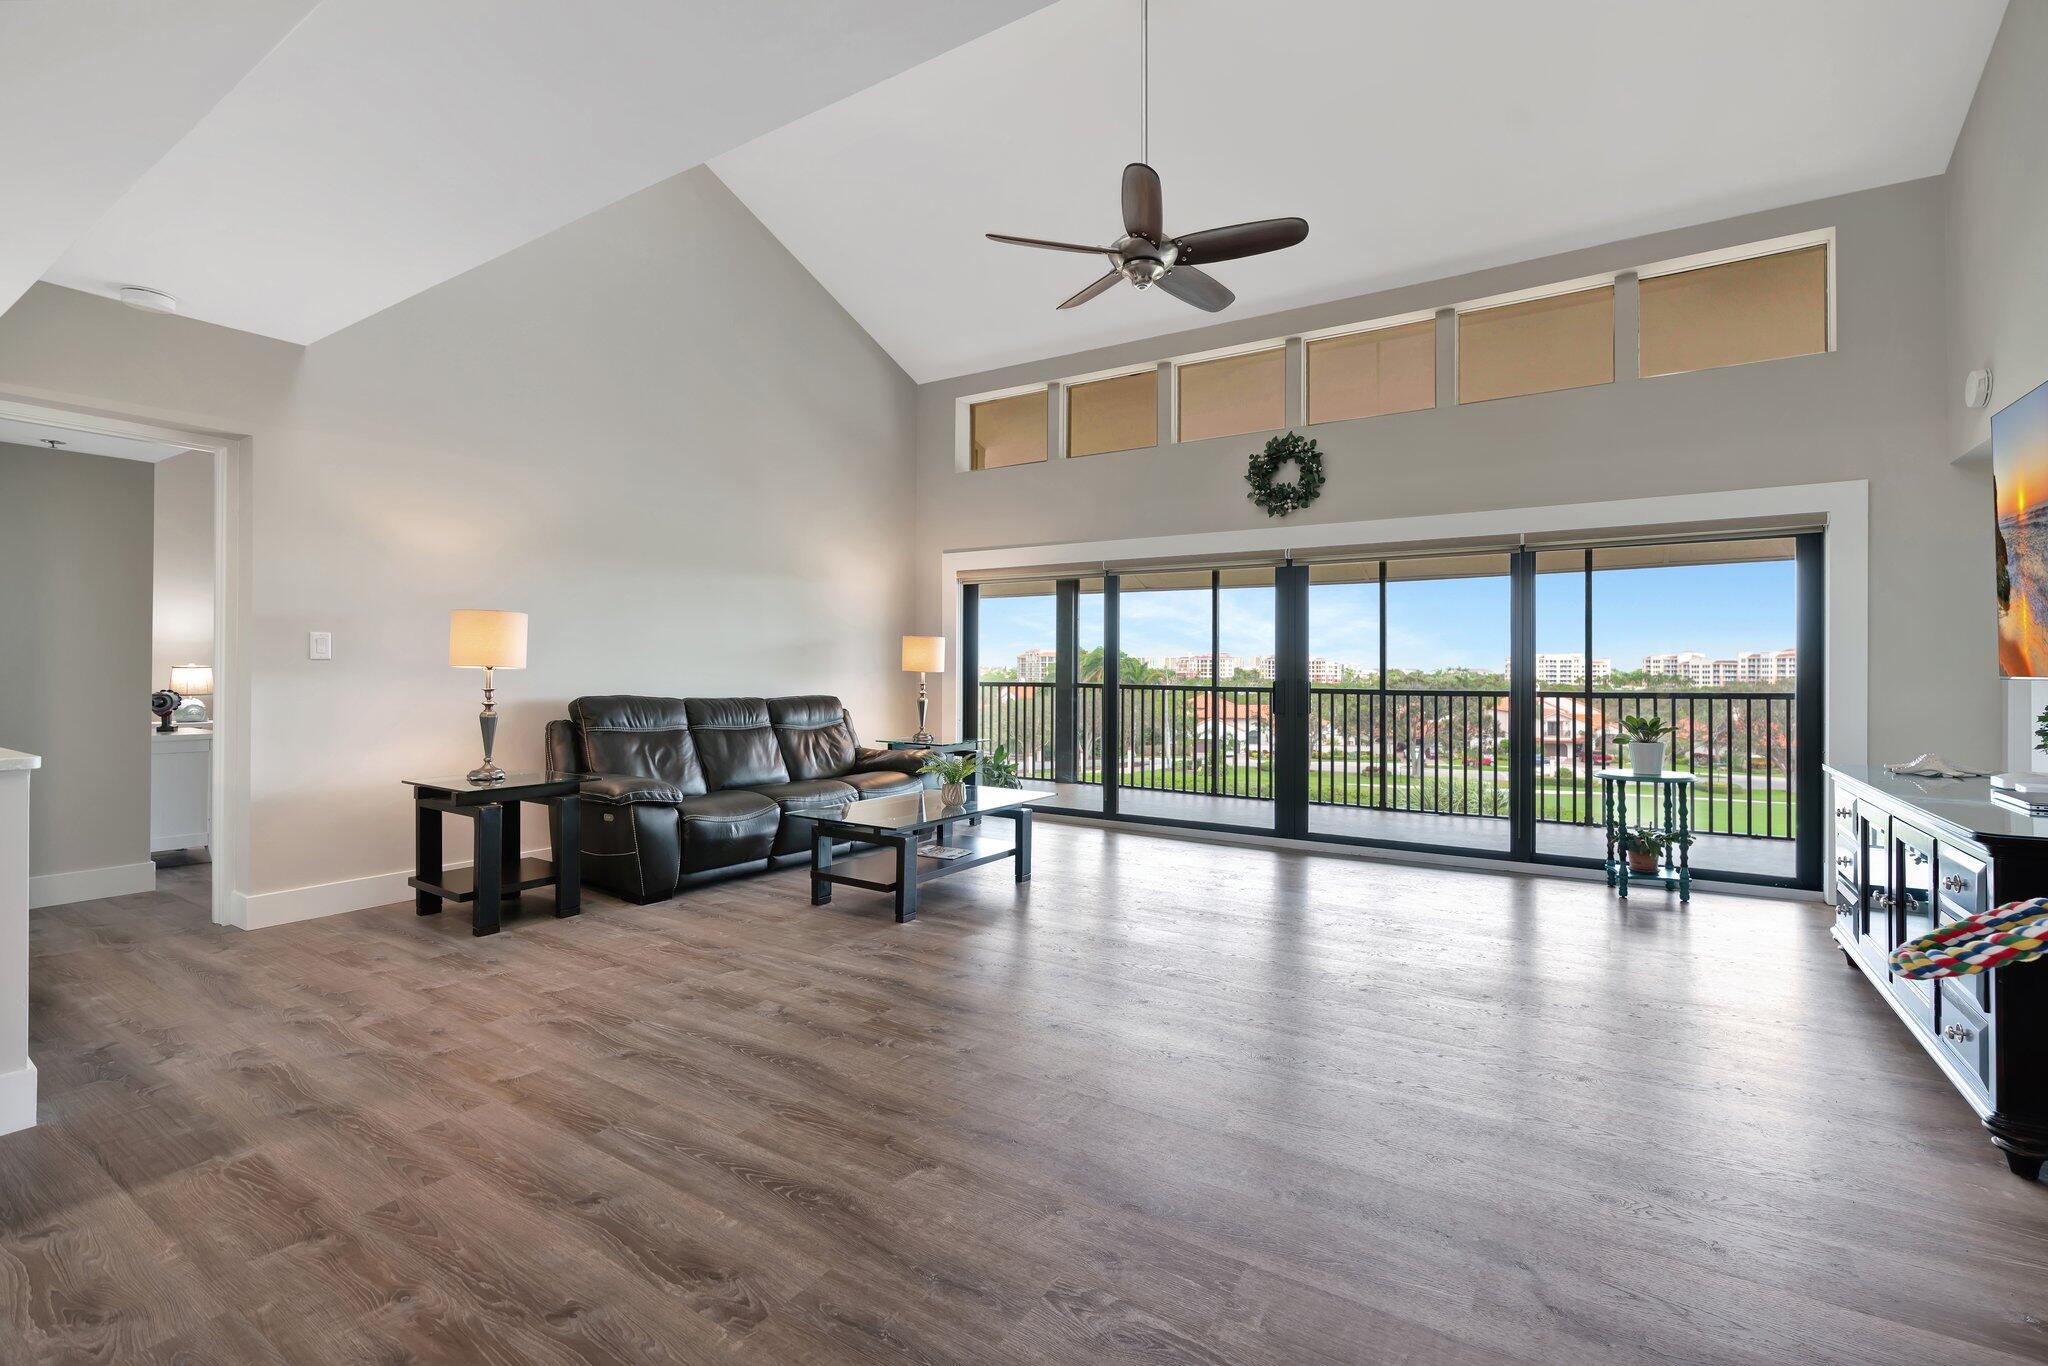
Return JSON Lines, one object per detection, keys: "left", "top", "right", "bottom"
{"left": 1636, "top": 246, "right": 1827, "bottom": 375}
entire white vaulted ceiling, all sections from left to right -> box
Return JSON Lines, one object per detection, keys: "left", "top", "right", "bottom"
{"left": 0, "top": 0, "right": 2005, "bottom": 381}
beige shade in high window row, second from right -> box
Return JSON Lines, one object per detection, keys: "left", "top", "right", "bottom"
{"left": 1458, "top": 285, "right": 1614, "bottom": 403}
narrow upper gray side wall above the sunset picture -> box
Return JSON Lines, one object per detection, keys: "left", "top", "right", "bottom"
{"left": 1942, "top": 0, "right": 2048, "bottom": 458}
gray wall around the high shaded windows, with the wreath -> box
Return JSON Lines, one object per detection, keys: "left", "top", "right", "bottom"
{"left": 918, "top": 180, "right": 2003, "bottom": 764}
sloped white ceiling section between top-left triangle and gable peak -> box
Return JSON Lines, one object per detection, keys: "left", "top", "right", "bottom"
{"left": 36, "top": 0, "right": 1042, "bottom": 342}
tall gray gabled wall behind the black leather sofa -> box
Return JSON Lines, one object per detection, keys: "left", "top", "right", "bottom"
{"left": 0, "top": 168, "right": 911, "bottom": 893}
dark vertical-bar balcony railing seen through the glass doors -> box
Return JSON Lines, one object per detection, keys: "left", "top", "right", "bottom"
{"left": 979, "top": 682, "right": 1798, "bottom": 840}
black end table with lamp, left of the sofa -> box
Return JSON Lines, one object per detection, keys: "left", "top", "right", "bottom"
{"left": 406, "top": 772, "right": 594, "bottom": 934}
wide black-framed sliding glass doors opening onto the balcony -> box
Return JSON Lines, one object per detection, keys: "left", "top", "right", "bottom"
{"left": 963, "top": 532, "right": 1821, "bottom": 885}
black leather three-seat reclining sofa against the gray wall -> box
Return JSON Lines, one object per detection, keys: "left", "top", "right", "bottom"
{"left": 547, "top": 696, "right": 928, "bottom": 903}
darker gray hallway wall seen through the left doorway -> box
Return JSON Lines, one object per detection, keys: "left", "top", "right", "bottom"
{"left": 0, "top": 444, "right": 152, "bottom": 877}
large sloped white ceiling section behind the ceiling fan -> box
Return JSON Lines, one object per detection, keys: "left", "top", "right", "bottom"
{"left": 713, "top": 0, "right": 2005, "bottom": 381}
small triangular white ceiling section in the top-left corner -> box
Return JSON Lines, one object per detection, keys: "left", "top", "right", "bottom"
{"left": 0, "top": 0, "right": 313, "bottom": 313}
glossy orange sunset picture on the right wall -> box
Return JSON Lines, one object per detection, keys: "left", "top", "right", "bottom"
{"left": 1991, "top": 376, "right": 2048, "bottom": 678}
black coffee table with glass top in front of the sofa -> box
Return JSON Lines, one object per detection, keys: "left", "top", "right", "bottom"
{"left": 811, "top": 786, "right": 1044, "bottom": 924}
